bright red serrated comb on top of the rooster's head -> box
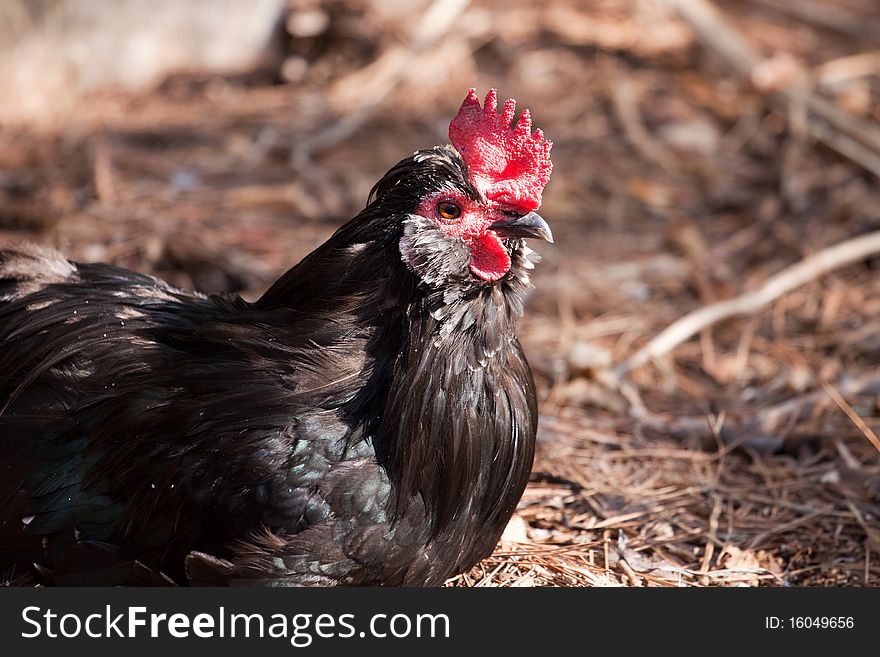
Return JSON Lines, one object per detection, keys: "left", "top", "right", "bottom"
{"left": 449, "top": 89, "right": 553, "bottom": 212}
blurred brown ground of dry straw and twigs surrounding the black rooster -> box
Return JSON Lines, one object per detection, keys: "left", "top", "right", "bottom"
{"left": 0, "top": 0, "right": 880, "bottom": 586}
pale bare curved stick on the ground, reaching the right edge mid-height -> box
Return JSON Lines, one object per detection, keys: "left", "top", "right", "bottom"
{"left": 614, "top": 231, "right": 880, "bottom": 378}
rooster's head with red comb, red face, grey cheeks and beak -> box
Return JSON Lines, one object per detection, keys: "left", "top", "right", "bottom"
{"left": 373, "top": 89, "right": 553, "bottom": 286}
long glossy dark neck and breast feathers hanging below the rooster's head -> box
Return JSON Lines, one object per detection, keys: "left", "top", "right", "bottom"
{"left": 377, "top": 266, "right": 537, "bottom": 568}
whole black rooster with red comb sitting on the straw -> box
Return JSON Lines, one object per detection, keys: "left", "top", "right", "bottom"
{"left": 0, "top": 90, "right": 552, "bottom": 585}
